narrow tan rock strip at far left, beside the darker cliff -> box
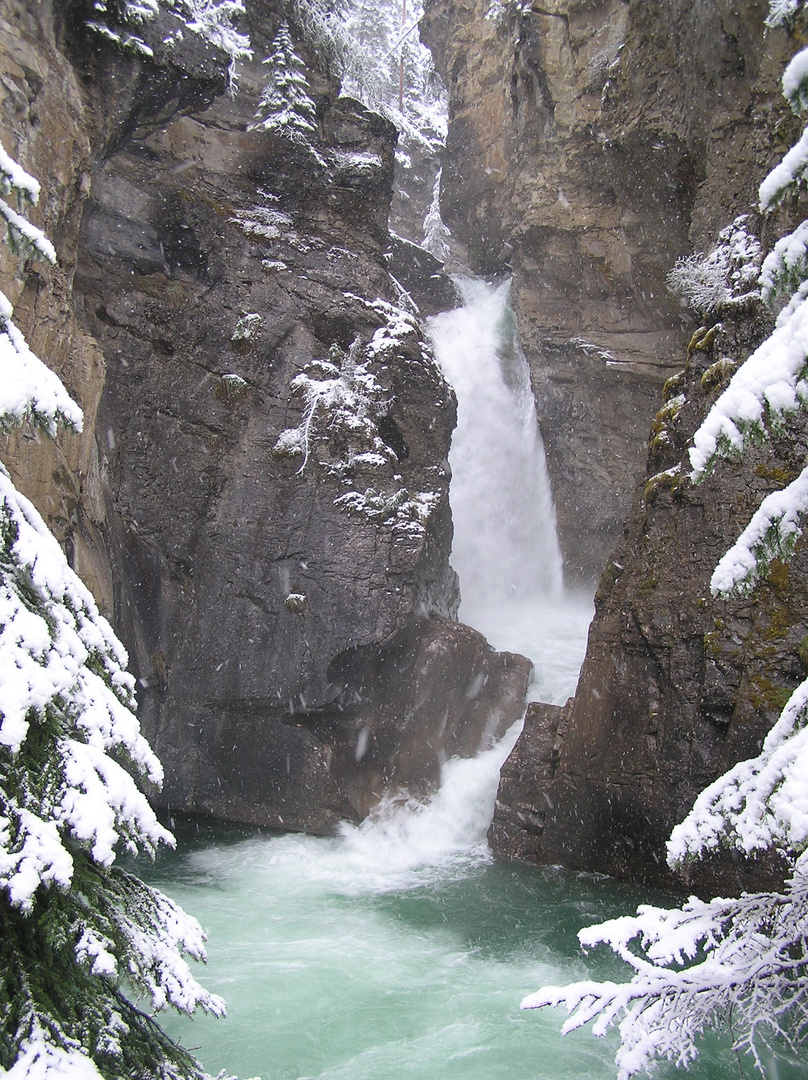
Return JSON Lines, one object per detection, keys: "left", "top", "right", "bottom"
{"left": 0, "top": 0, "right": 112, "bottom": 611}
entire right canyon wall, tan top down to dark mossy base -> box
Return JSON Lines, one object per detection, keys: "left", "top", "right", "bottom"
{"left": 425, "top": 0, "right": 808, "bottom": 888}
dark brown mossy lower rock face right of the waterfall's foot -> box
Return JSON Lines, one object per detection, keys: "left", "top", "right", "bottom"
{"left": 494, "top": 308, "right": 808, "bottom": 889}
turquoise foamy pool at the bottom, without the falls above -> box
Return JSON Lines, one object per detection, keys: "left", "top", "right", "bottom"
{"left": 146, "top": 814, "right": 751, "bottom": 1080}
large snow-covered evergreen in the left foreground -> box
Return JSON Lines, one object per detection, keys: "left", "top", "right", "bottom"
{"left": 0, "top": 146, "right": 224, "bottom": 1080}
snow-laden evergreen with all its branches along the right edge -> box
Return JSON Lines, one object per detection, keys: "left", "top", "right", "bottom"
{"left": 523, "top": 0, "right": 808, "bottom": 1078}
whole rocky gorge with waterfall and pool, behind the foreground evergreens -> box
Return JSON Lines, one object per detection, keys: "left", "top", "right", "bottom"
{"left": 0, "top": 0, "right": 808, "bottom": 1080}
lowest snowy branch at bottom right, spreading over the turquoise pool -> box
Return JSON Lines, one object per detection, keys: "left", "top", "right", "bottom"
{"left": 522, "top": 872, "right": 808, "bottom": 1080}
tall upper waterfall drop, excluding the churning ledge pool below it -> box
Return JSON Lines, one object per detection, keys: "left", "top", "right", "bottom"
{"left": 430, "top": 279, "right": 563, "bottom": 621}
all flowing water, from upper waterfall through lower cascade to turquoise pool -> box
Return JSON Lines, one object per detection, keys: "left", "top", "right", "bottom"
{"left": 141, "top": 282, "right": 808, "bottom": 1080}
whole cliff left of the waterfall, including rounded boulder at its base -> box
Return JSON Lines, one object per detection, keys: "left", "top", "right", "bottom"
{"left": 0, "top": 0, "right": 529, "bottom": 831}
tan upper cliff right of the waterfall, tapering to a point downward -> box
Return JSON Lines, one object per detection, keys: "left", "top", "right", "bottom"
{"left": 422, "top": 0, "right": 784, "bottom": 583}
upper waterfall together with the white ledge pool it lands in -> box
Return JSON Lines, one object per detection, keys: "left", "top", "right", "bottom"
{"left": 429, "top": 279, "right": 592, "bottom": 702}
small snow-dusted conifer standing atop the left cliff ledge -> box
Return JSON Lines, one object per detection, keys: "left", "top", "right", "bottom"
{"left": 250, "top": 23, "right": 317, "bottom": 143}
